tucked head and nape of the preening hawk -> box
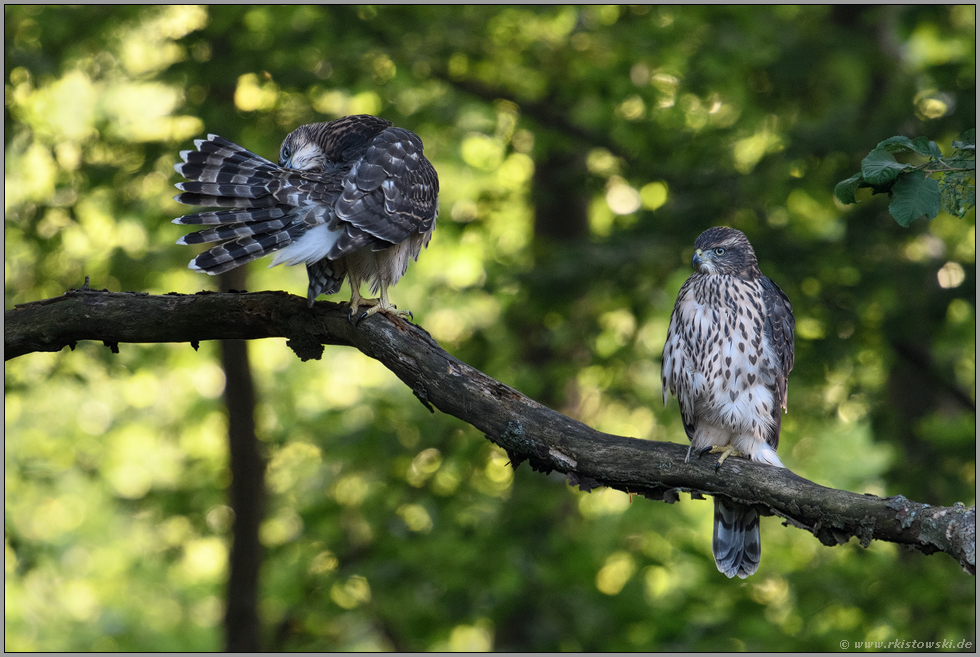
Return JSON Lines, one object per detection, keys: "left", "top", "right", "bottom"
{"left": 279, "top": 114, "right": 392, "bottom": 173}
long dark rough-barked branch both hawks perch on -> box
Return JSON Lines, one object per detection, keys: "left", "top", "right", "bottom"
{"left": 4, "top": 289, "right": 976, "bottom": 574}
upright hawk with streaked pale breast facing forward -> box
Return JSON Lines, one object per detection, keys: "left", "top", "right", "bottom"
{"left": 662, "top": 227, "right": 796, "bottom": 579}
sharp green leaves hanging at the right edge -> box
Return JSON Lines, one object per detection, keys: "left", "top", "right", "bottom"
{"left": 834, "top": 128, "right": 977, "bottom": 228}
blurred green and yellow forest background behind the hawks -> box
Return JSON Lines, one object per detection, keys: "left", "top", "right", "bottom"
{"left": 4, "top": 5, "right": 976, "bottom": 651}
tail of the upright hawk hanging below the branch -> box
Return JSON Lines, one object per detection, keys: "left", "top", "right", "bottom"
{"left": 711, "top": 497, "right": 762, "bottom": 579}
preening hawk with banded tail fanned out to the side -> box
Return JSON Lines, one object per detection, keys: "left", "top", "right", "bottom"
{"left": 174, "top": 115, "right": 439, "bottom": 320}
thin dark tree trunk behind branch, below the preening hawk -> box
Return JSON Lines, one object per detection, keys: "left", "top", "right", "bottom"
{"left": 221, "top": 268, "right": 265, "bottom": 652}
